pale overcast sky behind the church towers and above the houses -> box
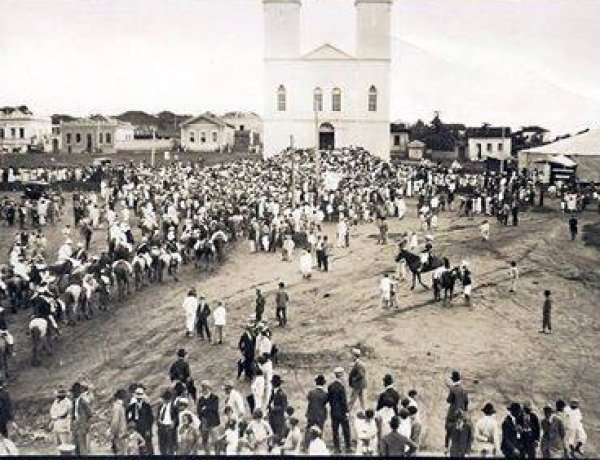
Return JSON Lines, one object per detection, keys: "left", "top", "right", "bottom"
{"left": 0, "top": 0, "right": 600, "bottom": 134}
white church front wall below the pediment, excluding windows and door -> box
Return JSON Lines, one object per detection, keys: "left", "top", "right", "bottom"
{"left": 264, "top": 59, "right": 390, "bottom": 158}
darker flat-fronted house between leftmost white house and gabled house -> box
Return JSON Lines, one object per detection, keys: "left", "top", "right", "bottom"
{"left": 60, "top": 115, "right": 134, "bottom": 153}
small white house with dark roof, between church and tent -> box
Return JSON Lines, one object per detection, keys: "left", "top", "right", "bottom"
{"left": 465, "top": 125, "right": 512, "bottom": 161}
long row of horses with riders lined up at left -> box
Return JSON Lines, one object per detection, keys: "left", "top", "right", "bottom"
{"left": 0, "top": 227, "right": 227, "bottom": 375}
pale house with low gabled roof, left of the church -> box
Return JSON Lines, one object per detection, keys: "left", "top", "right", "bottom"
{"left": 181, "top": 112, "right": 235, "bottom": 152}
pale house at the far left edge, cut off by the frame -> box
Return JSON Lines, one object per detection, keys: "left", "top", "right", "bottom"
{"left": 0, "top": 105, "right": 52, "bottom": 153}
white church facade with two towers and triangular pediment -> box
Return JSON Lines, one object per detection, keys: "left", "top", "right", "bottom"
{"left": 263, "top": 0, "right": 393, "bottom": 158}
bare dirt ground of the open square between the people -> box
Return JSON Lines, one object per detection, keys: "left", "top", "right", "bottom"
{"left": 0, "top": 193, "right": 600, "bottom": 455}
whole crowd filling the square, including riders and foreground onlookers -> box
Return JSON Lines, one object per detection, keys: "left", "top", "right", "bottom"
{"left": 0, "top": 146, "right": 585, "bottom": 456}
